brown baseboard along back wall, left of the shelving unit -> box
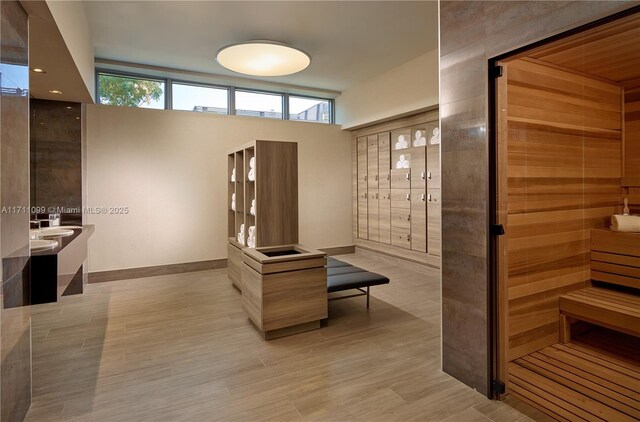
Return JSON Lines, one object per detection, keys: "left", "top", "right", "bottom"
{"left": 89, "top": 259, "right": 227, "bottom": 283}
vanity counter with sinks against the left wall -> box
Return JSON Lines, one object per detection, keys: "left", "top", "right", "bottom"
{"left": 31, "top": 225, "right": 94, "bottom": 305}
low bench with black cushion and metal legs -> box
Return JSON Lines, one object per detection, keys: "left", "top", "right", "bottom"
{"left": 327, "top": 258, "right": 389, "bottom": 308}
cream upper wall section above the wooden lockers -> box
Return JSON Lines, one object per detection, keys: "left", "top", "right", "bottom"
{"left": 336, "top": 50, "right": 439, "bottom": 129}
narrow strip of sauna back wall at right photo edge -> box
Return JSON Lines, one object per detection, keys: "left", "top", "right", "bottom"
{"left": 624, "top": 86, "right": 640, "bottom": 179}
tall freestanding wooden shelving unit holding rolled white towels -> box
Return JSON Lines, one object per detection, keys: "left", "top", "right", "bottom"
{"left": 227, "top": 140, "right": 298, "bottom": 290}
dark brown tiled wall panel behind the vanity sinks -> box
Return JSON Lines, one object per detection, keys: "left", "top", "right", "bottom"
{"left": 30, "top": 99, "right": 82, "bottom": 224}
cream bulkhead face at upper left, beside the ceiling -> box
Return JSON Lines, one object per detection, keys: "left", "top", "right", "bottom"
{"left": 47, "top": 0, "right": 95, "bottom": 101}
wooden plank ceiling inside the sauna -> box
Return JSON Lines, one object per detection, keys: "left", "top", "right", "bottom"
{"left": 526, "top": 12, "right": 640, "bottom": 86}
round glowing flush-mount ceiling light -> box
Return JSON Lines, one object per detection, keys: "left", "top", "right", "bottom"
{"left": 216, "top": 41, "right": 311, "bottom": 76}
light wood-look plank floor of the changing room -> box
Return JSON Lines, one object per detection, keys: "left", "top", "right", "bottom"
{"left": 27, "top": 254, "right": 545, "bottom": 422}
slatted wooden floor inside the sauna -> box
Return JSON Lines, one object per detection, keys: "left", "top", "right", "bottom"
{"left": 509, "top": 330, "right": 640, "bottom": 422}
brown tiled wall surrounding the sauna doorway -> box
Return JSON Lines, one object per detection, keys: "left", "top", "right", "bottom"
{"left": 440, "top": 0, "right": 638, "bottom": 395}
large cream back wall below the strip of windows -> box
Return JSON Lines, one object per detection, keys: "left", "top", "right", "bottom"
{"left": 86, "top": 105, "right": 353, "bottom": 272}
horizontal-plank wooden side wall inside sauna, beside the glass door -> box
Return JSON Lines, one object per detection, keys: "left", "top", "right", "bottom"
{"left": 506, "top": 59, "right": 622, "bottom": 360}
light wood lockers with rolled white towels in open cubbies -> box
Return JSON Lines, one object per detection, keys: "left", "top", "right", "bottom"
{"left": 353, "top": 111, "right": 441, "bottom": 267}
